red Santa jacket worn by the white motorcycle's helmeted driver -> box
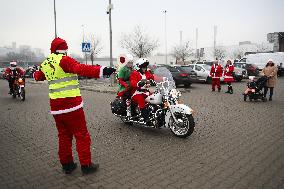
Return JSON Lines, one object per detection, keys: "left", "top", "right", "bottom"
{"left": 129, "top": 70, "right": 154, "bottom": 94}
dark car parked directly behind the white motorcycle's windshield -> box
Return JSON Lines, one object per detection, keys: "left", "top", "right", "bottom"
{"left": 158, "top": 65, "right": 197, "bottom": 87}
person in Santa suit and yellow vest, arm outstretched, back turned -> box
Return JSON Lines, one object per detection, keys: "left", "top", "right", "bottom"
{"left": 34, "top": 38, "right": 115, "bottom": 174}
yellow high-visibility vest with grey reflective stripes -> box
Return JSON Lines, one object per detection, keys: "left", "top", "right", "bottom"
{"left": 40, "top": 53, "right": 81, "bottom": 99}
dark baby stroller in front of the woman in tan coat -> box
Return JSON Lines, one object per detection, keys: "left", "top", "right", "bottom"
{"left": 243, "top": 76, "right": 268, "bottom": 101}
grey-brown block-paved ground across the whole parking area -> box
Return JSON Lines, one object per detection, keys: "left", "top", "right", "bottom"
{"left": 0, "top": 78, "right": 284, "bottom": 189}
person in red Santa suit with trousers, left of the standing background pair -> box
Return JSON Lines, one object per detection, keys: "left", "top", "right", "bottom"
{"left": 210, "top": 60, "right": 223, "bottom": 92}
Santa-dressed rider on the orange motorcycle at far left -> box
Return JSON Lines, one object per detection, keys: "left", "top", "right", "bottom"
{"left": 4, "top": 61, "right": 25, "bottom": 94}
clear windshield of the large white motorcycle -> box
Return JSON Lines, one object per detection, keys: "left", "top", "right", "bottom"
{"left": 154, "top": 67, "right": 176, "bottom": 94}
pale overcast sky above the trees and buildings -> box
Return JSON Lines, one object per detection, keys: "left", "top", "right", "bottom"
{"left": 0, "top": 0, "right": 284, "bottom": 56}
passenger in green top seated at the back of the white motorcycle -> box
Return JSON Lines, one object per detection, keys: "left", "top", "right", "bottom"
{"left": 117, "top": 54, "right": 133, "bottom": 99}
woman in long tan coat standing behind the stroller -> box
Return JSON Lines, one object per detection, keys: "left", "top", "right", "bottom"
{"left": 261, "top": 59, "right": 277, "bottom": 101}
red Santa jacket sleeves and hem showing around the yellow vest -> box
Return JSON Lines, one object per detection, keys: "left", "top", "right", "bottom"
{"left": 34, "top": 56, "right": 104, "bottom": 114}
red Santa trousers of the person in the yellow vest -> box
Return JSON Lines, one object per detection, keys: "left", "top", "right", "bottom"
{"left": 53, "top": 108, "right": 91, "bottom": 166}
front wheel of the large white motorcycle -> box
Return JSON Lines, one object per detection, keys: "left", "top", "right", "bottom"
{"left": 169, "top": 113, "right": 195, "bottom": 138}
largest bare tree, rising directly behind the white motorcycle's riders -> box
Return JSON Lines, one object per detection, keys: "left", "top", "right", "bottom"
{"left": 120, "top": 26, "right": 158, "bottom": 58}
